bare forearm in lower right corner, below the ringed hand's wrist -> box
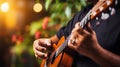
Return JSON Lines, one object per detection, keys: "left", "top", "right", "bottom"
{"left": 90, "top": 44, "right": 120, "bottom": 67}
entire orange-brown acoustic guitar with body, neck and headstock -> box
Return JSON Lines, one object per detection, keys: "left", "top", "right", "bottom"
{"left": 40, "top": 0, "right": 113, "bottom": 67}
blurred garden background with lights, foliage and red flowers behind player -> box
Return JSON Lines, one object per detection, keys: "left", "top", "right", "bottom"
{"left": 0, "top": 0, "right": 86, "bottom": 67}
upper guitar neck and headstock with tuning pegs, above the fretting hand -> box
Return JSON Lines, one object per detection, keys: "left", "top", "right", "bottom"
{"left": 80, "top": 0, "right": 113, "bottom": 29}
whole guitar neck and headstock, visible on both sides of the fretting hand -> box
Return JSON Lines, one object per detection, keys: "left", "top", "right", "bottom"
{"left": 55, "top": 0, "right": 113, "bottom": 57}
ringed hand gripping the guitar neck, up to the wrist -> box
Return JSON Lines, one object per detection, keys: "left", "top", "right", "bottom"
{"left": 68, "top": 23, "right": 98, "bottom": 56}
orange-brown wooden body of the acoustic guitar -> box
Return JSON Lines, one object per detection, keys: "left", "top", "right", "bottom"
{"left": 40, "top": 36, "right": 73, "bottom": 67}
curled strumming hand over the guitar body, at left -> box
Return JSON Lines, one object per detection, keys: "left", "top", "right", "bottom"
{"left": 33, "top": 39, "right": 52, "bottom": 59}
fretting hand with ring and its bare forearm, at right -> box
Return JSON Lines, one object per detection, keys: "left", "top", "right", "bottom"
{"left": 68, "top": 24, "right": 120, "bottom": 67}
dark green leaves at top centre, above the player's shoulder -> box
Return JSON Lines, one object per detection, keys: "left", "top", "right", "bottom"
{"left": 45, "top": 0, "right": 86, "bottom": 26}
